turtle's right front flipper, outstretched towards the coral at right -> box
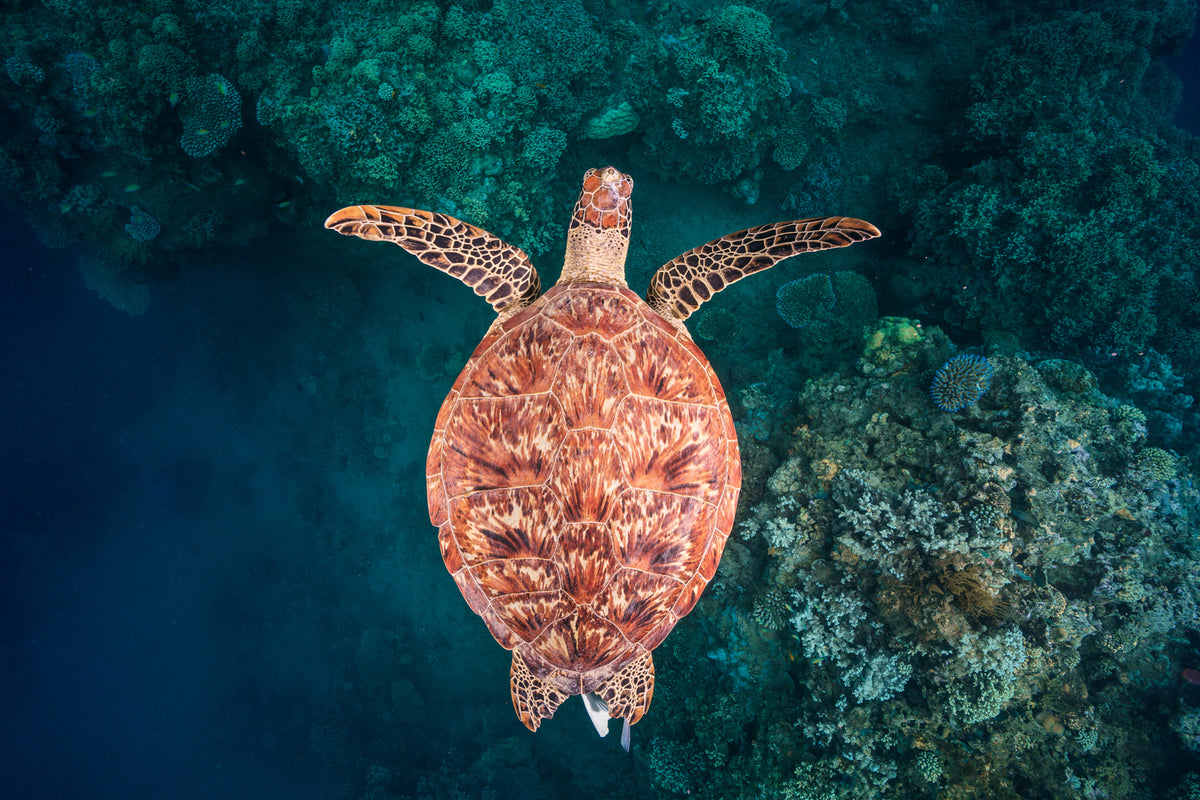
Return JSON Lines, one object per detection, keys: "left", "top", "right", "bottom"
{"left": 646, "top": 217, "right": 880, "bottom": 321}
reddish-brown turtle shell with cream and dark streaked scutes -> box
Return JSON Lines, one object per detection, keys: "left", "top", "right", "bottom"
{"left": 426, "top": 283, "right": 742, "bottom": 694}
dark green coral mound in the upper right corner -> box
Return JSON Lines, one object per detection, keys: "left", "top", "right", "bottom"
{"left": 914, "top": 2, "right": 1198, "bottom": 367}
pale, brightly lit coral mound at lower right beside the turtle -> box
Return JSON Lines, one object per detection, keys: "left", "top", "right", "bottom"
{"left": 658, "top": 319, "right": 1200, "bottom": 798}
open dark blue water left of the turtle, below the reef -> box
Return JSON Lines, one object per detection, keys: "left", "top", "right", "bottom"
{"left": 0, "top": 209, "right": 644, "bottom": 798}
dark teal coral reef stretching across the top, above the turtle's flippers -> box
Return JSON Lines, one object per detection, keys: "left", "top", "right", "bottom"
{"left": 0, "top": 0, "right": 1200, "bottom": 388}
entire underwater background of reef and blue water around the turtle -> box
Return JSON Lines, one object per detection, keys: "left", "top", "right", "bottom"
{"left": 0, "top": 0, "right": 1200, "bottom": 800}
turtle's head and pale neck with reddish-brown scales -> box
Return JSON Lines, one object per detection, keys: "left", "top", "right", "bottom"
{"left": 559, "top": 167, "right": 634, "bottom": 285}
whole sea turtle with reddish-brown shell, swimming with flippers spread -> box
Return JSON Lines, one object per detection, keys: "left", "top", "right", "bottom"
{"left": 325, "top": 167, "right": 880, "bottom": 750}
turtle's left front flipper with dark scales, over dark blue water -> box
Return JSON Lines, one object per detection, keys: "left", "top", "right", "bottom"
{"left": 325, "top": 205, "right": 541, "bottom": 317}
